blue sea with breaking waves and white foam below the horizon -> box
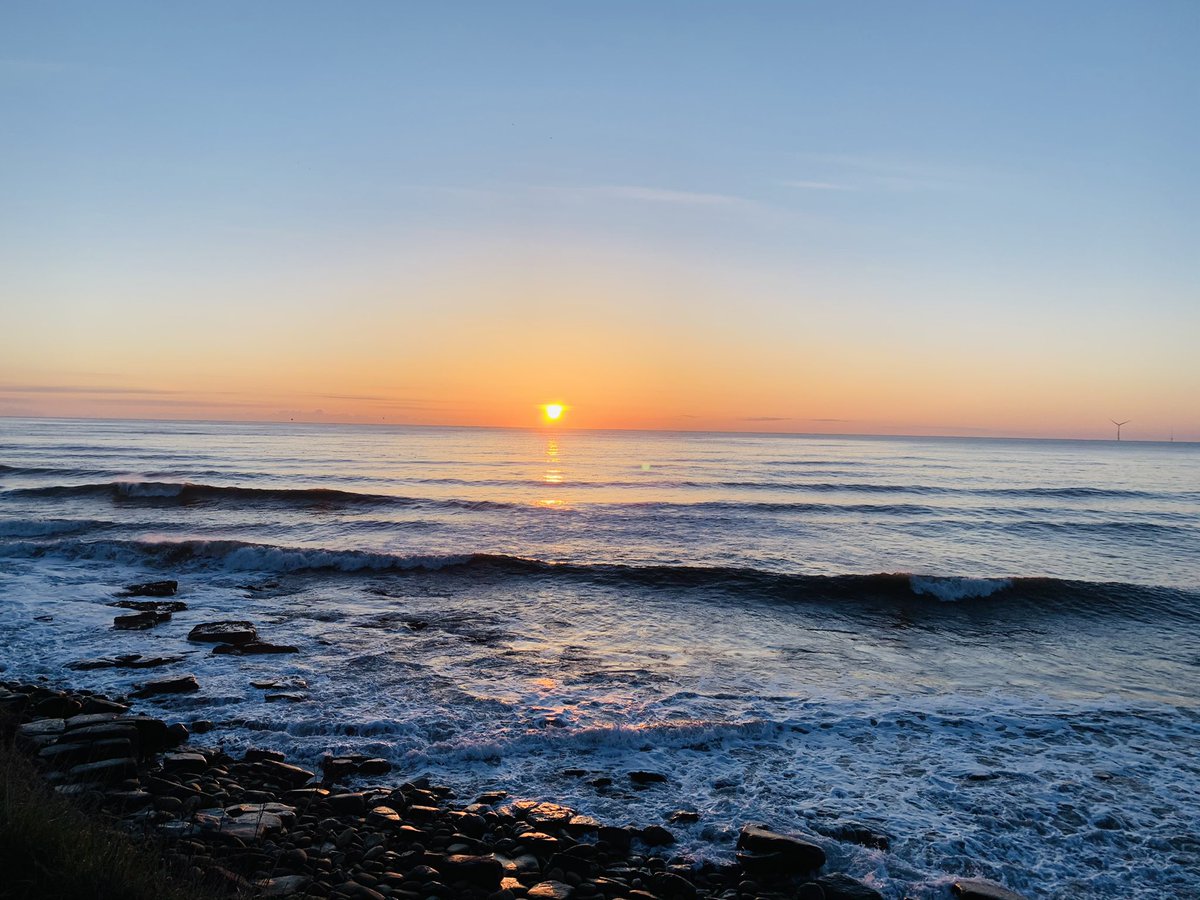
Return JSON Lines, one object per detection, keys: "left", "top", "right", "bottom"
{"left": 0, "top": 419, "right": 1200, "bottom": 898}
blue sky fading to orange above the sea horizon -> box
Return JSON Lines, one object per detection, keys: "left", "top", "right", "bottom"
{"left": 0, "top": 0, "right": 1200, "bottom": 439}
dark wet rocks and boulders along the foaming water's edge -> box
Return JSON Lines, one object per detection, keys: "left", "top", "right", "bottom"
{"left": 0, "top": 582, "right": 1021, "bottom": 900}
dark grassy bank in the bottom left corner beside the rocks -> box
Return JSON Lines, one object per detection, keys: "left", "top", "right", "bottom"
{"left": 0, "top": 728, "right": 225, "bottom": 900}
